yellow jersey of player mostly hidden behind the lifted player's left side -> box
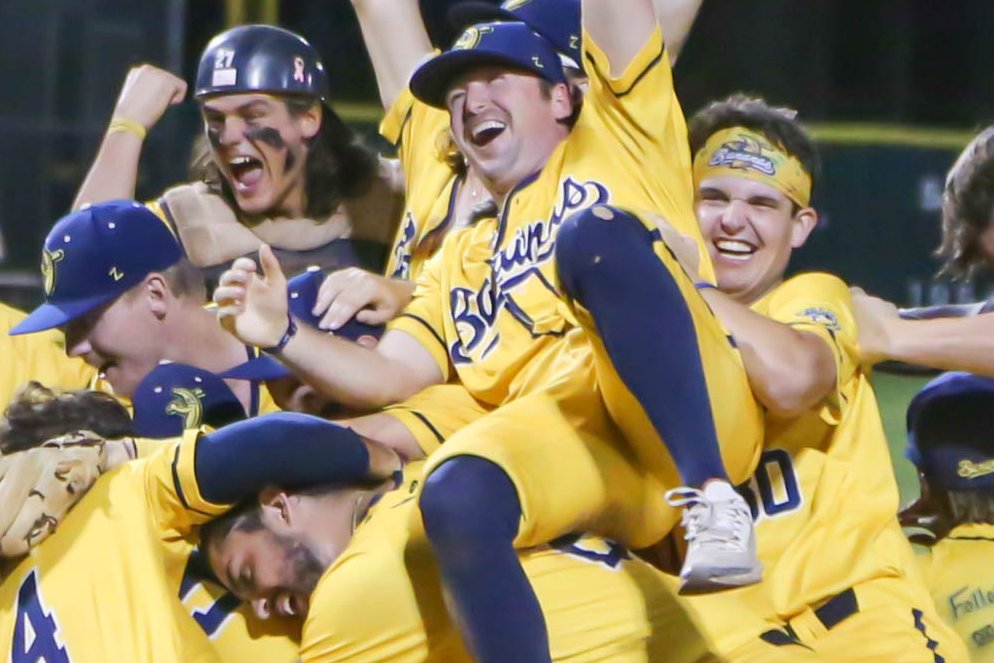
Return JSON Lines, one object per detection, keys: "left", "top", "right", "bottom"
{"left": 380, "top": 90, "right": 463, "bottom": 281}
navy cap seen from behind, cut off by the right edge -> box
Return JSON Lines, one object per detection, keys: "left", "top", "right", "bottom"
{"left": 905, "top": 373, "right": 994, "bottom": 490}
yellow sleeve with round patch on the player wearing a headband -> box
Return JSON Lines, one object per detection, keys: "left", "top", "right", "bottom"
{"left": 754, "top": 273, "right": 859, "bottom": 425}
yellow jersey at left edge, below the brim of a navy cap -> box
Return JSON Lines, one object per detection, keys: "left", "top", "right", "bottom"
{"left": 0, "top": 303, "right": 96, "bottom": 404}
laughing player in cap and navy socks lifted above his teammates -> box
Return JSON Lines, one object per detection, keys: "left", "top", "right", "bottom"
{"left": 215, "top": 0, "right": 761, "bottom": 661}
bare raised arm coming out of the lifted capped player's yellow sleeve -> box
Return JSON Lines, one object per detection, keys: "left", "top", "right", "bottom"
{"left": 581, "top": 0, "right": 656, "bottom": 76}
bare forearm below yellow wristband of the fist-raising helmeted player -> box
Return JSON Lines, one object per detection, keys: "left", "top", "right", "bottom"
{"left": 72, "top": 131, "right": 143, "bottom": 210}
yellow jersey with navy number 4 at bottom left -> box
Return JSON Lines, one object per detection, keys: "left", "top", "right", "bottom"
{"left": 0, "top": 433, "right": 297, "bottom": 663}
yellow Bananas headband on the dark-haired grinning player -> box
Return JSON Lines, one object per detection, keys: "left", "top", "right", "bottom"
{"left": 694, "top": 127, "right": 811, "bottom": 207}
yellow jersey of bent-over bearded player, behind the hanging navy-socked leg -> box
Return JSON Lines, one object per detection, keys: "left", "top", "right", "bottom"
{"left": 300, "top": 464, "right": 711, "bottom": 663}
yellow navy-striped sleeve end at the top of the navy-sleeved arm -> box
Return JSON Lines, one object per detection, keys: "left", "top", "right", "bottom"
{"left": 145, "top": 429, "right": 231, "bottom": 534}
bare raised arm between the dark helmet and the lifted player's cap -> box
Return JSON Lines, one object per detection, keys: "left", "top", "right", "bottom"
{"left": 352, "top": 0, "right": 432, "bottom": 109}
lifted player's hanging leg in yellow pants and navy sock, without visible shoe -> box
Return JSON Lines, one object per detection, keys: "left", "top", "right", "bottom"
{"left": 420, "top": 387, "right": 674, "bottom": 662}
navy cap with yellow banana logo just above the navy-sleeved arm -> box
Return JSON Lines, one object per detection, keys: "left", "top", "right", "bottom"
{"left": 131, "top": 362, "right": 245, "bottom": 438}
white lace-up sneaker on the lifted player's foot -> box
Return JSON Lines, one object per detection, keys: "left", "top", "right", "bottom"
{"left": 666, "top": 481, "right": 763, "bottom": 594}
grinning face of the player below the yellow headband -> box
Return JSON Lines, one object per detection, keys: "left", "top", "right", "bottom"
{"left": 696, "top": 176, "right": 818, "bottom": 304}
